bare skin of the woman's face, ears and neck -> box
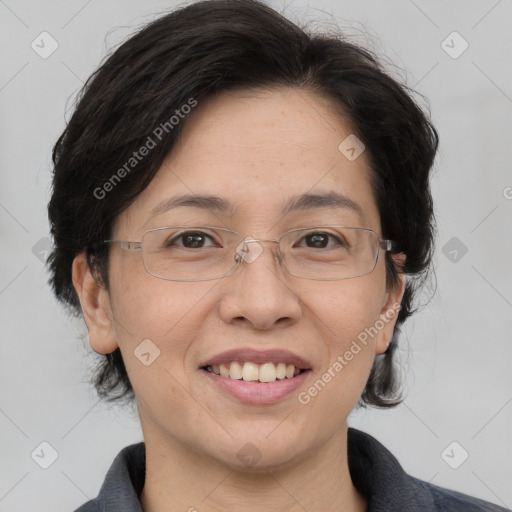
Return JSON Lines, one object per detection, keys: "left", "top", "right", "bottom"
{"left": 73, "top": 88, "right": 404, "bottom": 512}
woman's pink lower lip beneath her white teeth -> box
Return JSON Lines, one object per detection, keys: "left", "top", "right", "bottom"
{"left": 200, "top": 369, "right": 310, "bottom": 404}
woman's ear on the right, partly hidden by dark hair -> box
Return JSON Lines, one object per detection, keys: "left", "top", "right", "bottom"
{"left": 375, "top": 253, "right": 406, "bottom": 354}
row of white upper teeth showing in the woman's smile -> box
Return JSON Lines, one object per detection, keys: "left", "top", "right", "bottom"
{"left": 206, "top": 361, "right": 300, "bottom": 382}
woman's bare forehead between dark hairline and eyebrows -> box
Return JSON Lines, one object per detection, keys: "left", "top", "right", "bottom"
{"left": 118, "top": 88, "right": 379, "bottom": 233}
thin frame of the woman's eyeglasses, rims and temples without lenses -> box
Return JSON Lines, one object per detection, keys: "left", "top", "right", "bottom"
{"left": 103, "top": 225, "right": 397, "bottom": 282}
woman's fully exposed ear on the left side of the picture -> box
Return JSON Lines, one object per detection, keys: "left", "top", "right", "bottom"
{"left": 72, "top": 251, "right": 119, "bottom": 354}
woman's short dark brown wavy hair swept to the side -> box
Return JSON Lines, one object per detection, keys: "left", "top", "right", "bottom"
{"left": 48, "top": 0, "right": 438, "bottom": 407}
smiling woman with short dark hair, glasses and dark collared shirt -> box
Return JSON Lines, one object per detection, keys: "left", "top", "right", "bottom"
{"left": 49, "top": 0, "right": 505, "bottom": 512}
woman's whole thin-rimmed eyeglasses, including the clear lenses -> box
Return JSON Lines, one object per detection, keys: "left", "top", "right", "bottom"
{"left": 104, "top": 226, "right": 395, "bottom": 281}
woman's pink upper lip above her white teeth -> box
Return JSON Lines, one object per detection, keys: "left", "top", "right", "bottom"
{"left": 199, "top": 348, "right": 311, "bottom": 370}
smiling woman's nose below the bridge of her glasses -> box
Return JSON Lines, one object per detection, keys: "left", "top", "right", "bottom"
{"left": 220, "top": 238, "right": 301, "bottom": 330}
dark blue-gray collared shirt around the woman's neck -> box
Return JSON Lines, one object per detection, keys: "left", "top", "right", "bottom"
{"left": 75, "top": 428, "right": 511, "bottom": 512}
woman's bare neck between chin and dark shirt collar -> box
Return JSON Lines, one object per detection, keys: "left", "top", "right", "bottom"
{"left": 141, "top": 427, "right": 366, "bottom": 512}
